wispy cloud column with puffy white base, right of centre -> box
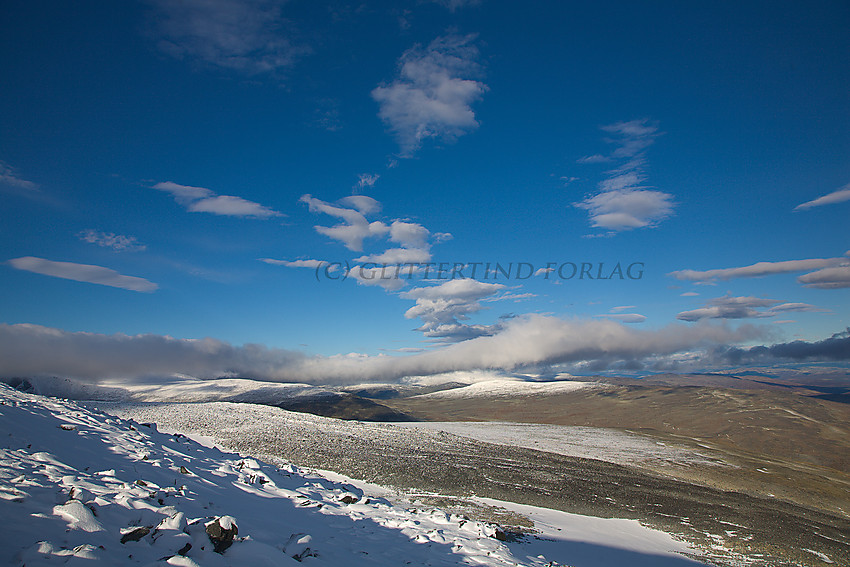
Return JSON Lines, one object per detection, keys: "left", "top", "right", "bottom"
{"left": 574, "top": 119, "right": 673, "bottom": 234}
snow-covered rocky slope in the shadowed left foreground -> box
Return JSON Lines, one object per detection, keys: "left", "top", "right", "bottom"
{"left": 0, "top": 385, "right": 698, "bottom": 567}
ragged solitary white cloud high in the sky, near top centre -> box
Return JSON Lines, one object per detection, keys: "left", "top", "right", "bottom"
{"left": 372, "top": 35, "right": 487, "bottom": 157}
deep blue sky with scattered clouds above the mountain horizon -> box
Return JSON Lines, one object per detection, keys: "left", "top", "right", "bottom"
{"left": 0, "top": 0, "right": 850, "bottom": 386}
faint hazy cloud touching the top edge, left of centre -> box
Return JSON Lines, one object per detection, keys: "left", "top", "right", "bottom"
{"left": 149, "top": 0, "right": 309, "bottom": 75}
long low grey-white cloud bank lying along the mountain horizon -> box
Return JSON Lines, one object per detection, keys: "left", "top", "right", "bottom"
{"left": 0, "top": 315, "right": 764, "bottom": 383}
